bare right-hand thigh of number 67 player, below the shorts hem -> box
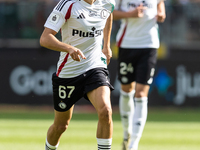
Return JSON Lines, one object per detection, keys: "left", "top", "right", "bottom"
{"left": 87, "top": 86, "right": 111, "bottom": 112}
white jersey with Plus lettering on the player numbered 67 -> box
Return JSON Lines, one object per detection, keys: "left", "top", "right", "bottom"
{"left": 44, "top": 0, "right": 115, "bottom": 78}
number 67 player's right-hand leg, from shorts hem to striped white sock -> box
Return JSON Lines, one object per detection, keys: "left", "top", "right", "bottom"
{"left": 87, "top": 86, "right": 113, "bottom": 150}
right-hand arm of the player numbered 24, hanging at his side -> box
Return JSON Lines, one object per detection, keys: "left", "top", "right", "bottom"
{"left": 156, "top": 1, "right": 166, "bottom": 23}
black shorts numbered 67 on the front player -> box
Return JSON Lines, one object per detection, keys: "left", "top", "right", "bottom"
{"left": 52, "top": 68, "right": 114, "bottom": 112}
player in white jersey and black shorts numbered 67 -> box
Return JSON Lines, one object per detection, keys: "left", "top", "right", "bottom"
{"left": 40, "top": 0, "right": 115, "bottom": 150}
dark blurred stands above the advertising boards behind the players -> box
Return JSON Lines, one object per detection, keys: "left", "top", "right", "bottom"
{"left": 0, "top": 0, "right": 200, "bottom": 48}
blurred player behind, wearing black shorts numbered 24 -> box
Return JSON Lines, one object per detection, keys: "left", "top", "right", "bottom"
{"left": 113, "top": 0, "right": 166, "bottom": 150}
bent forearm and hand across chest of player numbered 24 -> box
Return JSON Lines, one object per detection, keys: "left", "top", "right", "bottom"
{"left": 113, "top": 4, "right": 146, "bottom": 20}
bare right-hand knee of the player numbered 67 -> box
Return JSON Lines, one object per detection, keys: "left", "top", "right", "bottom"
{"left": 98, "top": 106, "right": 112, "bottom": 122}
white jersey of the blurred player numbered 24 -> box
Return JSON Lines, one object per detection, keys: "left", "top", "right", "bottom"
{"left": 115, "top": 0, "right": 163, "bottom": 48}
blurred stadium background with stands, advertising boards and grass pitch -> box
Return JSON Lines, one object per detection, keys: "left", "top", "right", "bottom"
{"left": 0, "top": 0, "right": 200, "bottom": 150}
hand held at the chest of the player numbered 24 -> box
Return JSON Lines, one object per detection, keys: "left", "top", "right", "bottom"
{"left": 128, "top": 4, "right": 147, "bottom": 18}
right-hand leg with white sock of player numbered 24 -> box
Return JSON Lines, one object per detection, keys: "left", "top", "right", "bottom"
{"left": 129, "top": 83, "right": 150, "bottom": 150}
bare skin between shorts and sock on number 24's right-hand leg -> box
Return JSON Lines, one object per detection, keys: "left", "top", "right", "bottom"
{"left": 135, "top": 83, "right": 150, "bottom": 97}
